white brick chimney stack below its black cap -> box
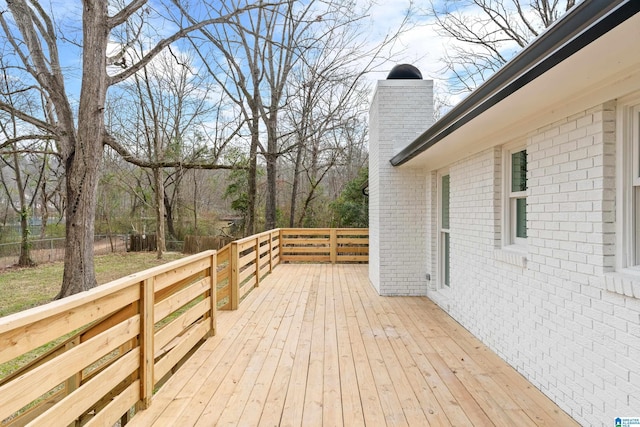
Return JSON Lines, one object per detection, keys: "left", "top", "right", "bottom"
{"left": 369, "top": 80, "right": 433, "bottom": 295}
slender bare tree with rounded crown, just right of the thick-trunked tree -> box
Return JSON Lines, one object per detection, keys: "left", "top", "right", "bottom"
{"left": 110, "top": 46, "right": 217, "bottom": 258}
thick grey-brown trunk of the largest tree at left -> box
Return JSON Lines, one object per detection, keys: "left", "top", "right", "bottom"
{"left": 57, "top": 0, "right": 109, "bottom": 298}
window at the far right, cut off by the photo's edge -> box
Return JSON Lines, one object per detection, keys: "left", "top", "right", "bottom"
{"left": 616, "top": 96, "right": 640, "bottom": 270}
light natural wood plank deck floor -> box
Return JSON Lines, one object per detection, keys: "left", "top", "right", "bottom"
{"left": 130, "top": 264, "right": 577, "bottom": 426}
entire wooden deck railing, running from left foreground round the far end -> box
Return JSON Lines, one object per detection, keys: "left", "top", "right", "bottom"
{"left": 0, "top": 229, "right": 368, "bottom": 426}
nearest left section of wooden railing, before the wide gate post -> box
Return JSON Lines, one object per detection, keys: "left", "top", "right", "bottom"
{"left": 0, "top": 251, "right": 217, "bottom": 426}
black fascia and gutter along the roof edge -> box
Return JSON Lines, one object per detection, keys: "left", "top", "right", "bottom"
{"left": 390, "top": 0, "right": 640, "bottom": 166}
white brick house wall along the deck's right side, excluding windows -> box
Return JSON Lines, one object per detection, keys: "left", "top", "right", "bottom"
{"left": 418, "top": 102, "right": 640, "bottom": 426}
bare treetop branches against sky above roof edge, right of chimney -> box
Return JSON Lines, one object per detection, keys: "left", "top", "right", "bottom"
{"left": 427, "top": 0, "right": 576, "bottom": 93}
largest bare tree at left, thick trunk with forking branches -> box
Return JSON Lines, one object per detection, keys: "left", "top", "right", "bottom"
{"left": 0, "top": 0, "right": 262, "bottom": 297}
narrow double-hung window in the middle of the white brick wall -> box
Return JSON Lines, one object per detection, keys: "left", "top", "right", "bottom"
{"left": 502, "top": 147, "right": 527, "bottom": 249}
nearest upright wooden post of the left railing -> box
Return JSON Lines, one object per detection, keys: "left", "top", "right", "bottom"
{"left": 138, "top": 277, "right": 155, "bottom": 409}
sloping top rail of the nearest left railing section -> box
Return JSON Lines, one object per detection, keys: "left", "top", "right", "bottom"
{"left": 0, "top": 250, "right": 216, "bottom": 334}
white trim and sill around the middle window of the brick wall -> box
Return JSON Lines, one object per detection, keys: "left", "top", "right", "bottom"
{"left": 501, "top": 142, "right": 528, "bottom": 255}
